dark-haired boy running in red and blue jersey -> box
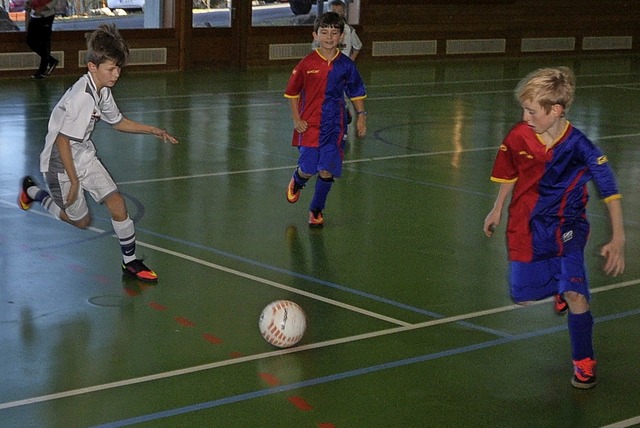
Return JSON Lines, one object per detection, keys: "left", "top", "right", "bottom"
{"left": 284, "top": 12, "right": 367, "bottom": 227}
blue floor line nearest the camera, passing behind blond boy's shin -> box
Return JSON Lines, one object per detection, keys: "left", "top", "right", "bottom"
{"left": 94, "top": 309, "right": 640, "bottom": 428}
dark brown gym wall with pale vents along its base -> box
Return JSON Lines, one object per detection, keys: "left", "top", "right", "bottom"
{"left": 0, "top": 0, "right": 640, "bottom": 77}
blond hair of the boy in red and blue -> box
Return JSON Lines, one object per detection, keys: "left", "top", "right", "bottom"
{"left": 515, "top": 67, "right": 576, "bottom": 113}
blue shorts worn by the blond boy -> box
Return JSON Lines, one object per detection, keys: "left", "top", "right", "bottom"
{"left": 509, "top": 252, "right": 590, "bottom": 303}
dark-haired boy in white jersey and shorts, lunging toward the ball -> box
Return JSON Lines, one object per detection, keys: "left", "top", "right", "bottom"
{"left": 18, "top": 24, "right": 178, "bottom": 281}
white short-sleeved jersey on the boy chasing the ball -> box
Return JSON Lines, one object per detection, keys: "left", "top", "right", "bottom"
{"left": 40, "top": 73, "right": 122, "bottom": 173}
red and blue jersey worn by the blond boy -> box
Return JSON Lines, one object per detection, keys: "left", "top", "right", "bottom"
{"left": 491, "top": 122, "right": 621, "bottom": 262}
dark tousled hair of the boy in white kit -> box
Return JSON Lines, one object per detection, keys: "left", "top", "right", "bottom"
{"left": 85, "top": 24, "right": 129, "bottom": 67}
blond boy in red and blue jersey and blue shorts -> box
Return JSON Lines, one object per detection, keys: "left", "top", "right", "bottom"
{"left": 484, "top": 67, "right": 625, "bottom": 389}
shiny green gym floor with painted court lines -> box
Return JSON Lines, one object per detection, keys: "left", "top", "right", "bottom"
{"left": 0, "top": 54, "right": 640, "bottom": 428}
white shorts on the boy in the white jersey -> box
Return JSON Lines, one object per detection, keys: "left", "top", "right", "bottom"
{"left": 43, "top": 158, "right": 118, "bottom": 221}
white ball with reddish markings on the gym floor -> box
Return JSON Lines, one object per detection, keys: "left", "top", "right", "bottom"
{"left": 258, "top": 300, "right": 307, "bottom": 348}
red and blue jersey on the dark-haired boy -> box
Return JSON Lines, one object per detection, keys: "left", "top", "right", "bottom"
{"left": 284, "top": 49, "right": 366, "bottom": 147}
